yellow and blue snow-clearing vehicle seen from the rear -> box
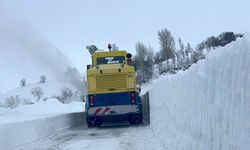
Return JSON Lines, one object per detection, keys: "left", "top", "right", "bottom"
{"left": 85, "top": 45, "right": 143, "bottom": 127}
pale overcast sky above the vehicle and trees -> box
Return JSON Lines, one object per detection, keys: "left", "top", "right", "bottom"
{"left": 3, "top": 0, "right": 250, "bottom": 72}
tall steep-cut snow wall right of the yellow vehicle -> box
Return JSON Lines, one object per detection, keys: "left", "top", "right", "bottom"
{"left": 121, "top": 35, "right": 250, "bottom": 150}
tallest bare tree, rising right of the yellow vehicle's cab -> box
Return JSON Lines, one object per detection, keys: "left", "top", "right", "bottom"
{"left": 158, "top": 29, "right": 175, "bottom": 60}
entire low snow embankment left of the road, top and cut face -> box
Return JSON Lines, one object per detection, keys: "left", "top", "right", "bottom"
{"left": 0, "top": 99, "right": 85, "bottom": 150}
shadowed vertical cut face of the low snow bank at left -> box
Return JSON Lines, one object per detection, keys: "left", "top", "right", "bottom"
{"left": 0, "top": 112, "right": 85, "bottom": 150}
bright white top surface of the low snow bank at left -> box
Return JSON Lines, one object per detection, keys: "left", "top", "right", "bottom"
{"left": 0, "top": 98, "right": 84, "bottom": 125}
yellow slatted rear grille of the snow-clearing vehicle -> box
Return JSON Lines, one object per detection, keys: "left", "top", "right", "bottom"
{"left": 96, "top": 75, "right": 127, "bottom": 91}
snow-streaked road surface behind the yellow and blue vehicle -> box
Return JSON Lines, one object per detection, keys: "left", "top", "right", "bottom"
{"left": 16, "top": 125, "right": 131, "bottom": 150}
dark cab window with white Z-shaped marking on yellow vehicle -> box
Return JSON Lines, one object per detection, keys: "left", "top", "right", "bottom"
{"left": 96, "top": 56, "right": 125, "bottom": 65}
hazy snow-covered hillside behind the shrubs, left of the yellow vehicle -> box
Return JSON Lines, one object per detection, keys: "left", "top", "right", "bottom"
{"left": 0, "top": 6, "right": 84, "bottom": 108}
